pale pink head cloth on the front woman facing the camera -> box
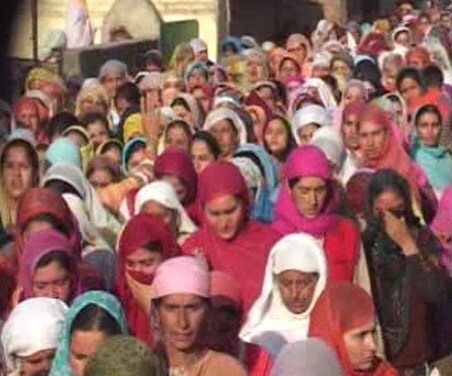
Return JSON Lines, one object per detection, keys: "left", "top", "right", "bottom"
{"left": 152, "top": 256, "right": 210, "bottom": 299}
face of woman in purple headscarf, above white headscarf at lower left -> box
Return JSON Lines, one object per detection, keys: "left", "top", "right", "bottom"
{"left": 33, "top": 261, "right": 71, "bottom": 302}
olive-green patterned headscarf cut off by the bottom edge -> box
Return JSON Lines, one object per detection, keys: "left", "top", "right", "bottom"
{"left": 85, "top": 335, "right": 164, "bottom": 376}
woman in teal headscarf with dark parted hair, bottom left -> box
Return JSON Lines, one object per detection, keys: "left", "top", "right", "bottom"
{"left": 49, "top": 291, "right": 127, "bottom": 376}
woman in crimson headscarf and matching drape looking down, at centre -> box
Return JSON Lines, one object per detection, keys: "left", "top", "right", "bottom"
{"left": 182, "top": 161, "right": 279, "bottom": 309}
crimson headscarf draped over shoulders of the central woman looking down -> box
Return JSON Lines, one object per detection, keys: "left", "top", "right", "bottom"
{"left": 183, "top": 161, "right": 279, "bottom": 311}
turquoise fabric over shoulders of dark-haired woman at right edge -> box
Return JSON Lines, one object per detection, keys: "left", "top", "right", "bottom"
{"left": 410, "top": 135, "right": 452, "bottom": 191}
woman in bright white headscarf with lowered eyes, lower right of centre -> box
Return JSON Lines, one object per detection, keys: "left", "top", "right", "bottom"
{"left": 240, "top": 234, "right": 327, "bottom": 358}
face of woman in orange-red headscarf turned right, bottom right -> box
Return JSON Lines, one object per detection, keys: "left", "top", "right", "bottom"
{"left": 342, "top": 321, "right": 377, "bottom": 371}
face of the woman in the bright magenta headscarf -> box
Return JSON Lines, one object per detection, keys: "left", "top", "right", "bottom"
{"left": 292, "top": 176, "right": 328, "bottom": 218}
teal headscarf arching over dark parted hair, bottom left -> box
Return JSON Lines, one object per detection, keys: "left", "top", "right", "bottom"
{"left": 49, "top": 291, "right": 127, "bottom": 376}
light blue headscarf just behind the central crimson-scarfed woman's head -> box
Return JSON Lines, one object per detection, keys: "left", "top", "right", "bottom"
{"left": 233, "top": 144, "right": 278, "bottom": 222}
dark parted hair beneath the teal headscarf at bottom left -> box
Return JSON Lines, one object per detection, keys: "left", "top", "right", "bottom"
{"left": 70, "top": 303, "right": 122, "bottom": 337}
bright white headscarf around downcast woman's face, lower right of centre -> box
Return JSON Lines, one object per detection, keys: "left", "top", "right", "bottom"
{"left": 240, "top": 233, "right": 327, "bottom": 357}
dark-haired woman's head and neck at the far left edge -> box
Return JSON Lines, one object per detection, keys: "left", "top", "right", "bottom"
{"left": 0, "top": 138, "right": 39, "bottom": 229}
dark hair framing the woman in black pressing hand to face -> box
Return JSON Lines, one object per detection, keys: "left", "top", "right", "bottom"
{"left": 366, "top": 168, "right": 419, "bottom": 225}
